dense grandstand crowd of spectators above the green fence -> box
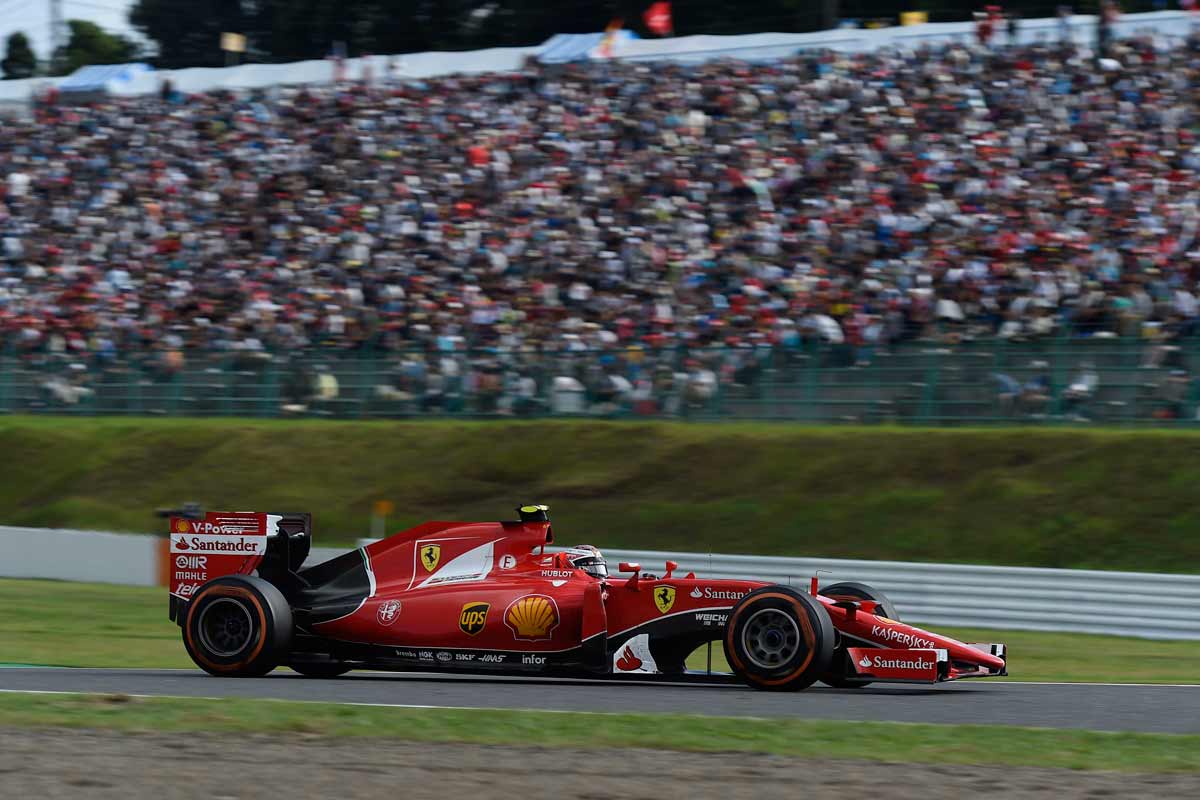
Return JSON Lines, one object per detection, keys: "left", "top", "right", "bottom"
{"left": 0, "top": 28, "right": 1200, "bottom": 412}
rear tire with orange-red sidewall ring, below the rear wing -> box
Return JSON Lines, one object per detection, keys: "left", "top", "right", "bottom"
{"left": 184, "top": 575, "right": 293, "bottom": 678}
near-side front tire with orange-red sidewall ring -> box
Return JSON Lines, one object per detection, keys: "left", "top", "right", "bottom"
{"left": 725, "top": 585, "right": 834, "bottom": 692}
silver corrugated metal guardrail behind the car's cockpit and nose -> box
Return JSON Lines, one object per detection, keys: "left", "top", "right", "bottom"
{"left": 592, "top": 551, "right": 1200, "bottom": 639}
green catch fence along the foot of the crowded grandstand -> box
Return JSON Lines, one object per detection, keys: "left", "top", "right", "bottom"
{"left": 7, "top": 336, "right": 1200, "bottom": 426}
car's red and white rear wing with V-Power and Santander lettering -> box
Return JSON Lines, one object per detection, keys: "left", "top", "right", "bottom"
{"left": 158, "top": 505, "right": 312, "bottom": 621}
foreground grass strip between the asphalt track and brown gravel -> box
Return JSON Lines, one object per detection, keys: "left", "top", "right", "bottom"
{"left": 0, "top": 694, "right": 1200, "bottom": 772}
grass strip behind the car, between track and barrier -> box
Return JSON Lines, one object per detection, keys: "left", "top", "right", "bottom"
{"left": 7, "top": 581, "right": 1200, "bottom": 684}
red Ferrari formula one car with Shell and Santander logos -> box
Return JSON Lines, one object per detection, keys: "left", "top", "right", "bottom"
{"left": 163, "top": 506, "right": 1007, "bottom": 690}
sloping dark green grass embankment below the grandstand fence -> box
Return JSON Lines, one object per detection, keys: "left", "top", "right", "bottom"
{"left": 0, "top": 417, "right": 1200, "bottom": 572}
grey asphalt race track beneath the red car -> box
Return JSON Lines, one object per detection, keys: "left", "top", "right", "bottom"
{"left": 0, "top": 668, "right": 1200, "bottom": 734}
